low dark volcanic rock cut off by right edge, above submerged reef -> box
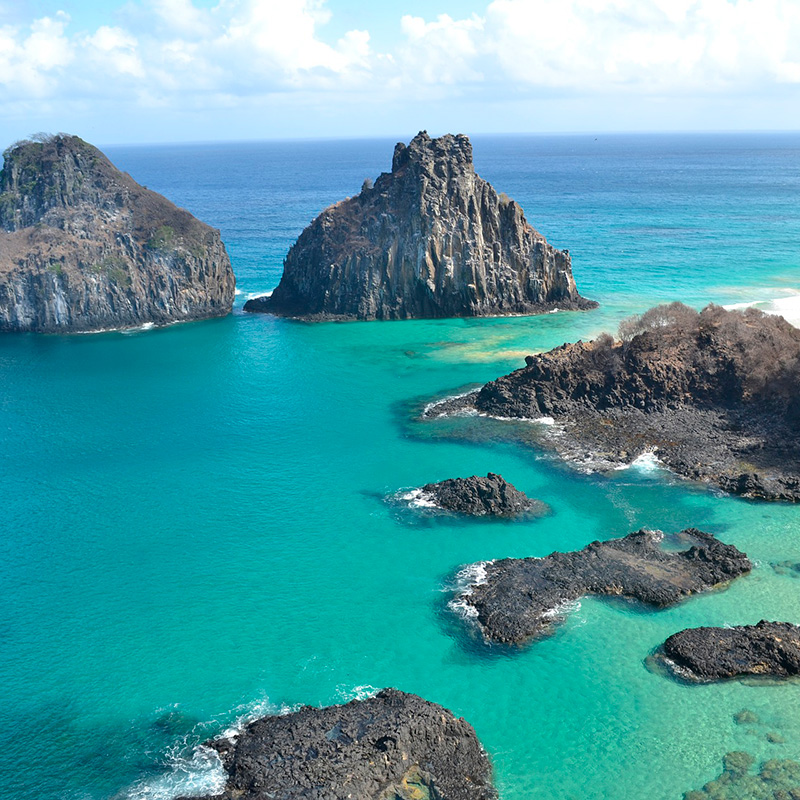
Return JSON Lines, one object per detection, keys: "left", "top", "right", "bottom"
{"left": 664, "top": 620, "right": 800, "bottom": 681}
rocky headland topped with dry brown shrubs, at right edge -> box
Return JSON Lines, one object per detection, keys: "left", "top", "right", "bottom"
{"left": 427, "top": 303, "right": 800, "bottom": 501}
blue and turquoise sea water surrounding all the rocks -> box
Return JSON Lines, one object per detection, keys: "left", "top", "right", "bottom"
{"left": 0, "top": 135, "right": 800, "bottom": 800}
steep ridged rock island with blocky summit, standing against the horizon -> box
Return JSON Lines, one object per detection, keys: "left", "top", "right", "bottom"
{"left": 245, "top": 132, "right": 596, "bottom": 319}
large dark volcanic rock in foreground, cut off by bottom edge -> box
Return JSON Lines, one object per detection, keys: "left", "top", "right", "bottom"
{"left": 183, "top": 689, "right": 497, "bottom": 800}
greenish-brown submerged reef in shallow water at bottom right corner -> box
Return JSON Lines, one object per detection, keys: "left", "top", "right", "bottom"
{"left": 683, "top": 750, "right": 800, "bottom": 800}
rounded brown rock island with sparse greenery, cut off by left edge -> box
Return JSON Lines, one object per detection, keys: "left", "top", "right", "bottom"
{"left": 0, "top": 135, "right": 235, "bottom": 332}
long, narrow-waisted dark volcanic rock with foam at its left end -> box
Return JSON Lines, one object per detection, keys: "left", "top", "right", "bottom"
{"left": 459, "top": 528, "right": 751, "bottom": 643}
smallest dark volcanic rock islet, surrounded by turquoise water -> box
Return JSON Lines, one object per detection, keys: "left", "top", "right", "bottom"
{"left": 421, "top": 472, "right": 534, "bottom": 516}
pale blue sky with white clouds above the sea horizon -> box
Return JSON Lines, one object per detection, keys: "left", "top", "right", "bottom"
{"left": 0, "top": 0, "right": 800, "bottom": 147}
